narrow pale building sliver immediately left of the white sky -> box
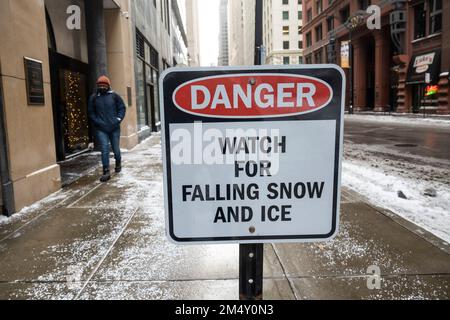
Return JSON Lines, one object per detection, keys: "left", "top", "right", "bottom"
{"left": 186, "top": 0, "right": 200, "bottom": 67}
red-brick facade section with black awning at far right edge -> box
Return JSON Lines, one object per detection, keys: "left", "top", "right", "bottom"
{"left": 406, "top": 0, "right": 450, "bottom": 114}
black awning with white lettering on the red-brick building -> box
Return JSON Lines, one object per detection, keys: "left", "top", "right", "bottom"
{"left": 406, "top": 49, "right": 441, "bottom": 84}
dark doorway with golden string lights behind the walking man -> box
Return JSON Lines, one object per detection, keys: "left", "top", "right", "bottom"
{"left": 49, "top": 50, "right": 93, "bottom": 162}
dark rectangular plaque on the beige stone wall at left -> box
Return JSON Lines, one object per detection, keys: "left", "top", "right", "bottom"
{"left": 24, "top": 57, "right": 45, "bottom": 105}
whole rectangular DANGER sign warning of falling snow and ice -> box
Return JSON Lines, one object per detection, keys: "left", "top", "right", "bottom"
{"left": 160, "top": 65, "right": 345, "bottom": 244}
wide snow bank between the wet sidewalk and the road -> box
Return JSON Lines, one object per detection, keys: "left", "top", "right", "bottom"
{"left": 343, "top": 143, "right": 450, "bottom": 242}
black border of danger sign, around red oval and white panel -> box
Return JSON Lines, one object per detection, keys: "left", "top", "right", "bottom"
{"left": 159, "top": 64, "right": 346, "bottom": 244}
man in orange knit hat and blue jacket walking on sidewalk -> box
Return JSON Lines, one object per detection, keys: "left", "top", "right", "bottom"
{"left": 88, "top": 76, "right": 126, "bottom": 182}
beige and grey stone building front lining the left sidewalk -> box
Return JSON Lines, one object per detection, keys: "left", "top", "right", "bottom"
{"left": 0, "top": 0, "right": 187, "bottom": 215}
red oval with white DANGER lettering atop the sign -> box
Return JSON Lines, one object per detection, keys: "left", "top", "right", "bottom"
{"left": 173, "top": 74, "right": 333, "bottom": 118}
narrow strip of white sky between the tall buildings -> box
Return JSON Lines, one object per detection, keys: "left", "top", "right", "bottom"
{"left": 198, "top": 0, "right": 220, "bottom": 67}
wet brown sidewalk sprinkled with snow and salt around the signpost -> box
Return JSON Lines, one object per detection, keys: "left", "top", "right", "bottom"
{"left": 0, "top": 137, "right": 450, "bottom": 300}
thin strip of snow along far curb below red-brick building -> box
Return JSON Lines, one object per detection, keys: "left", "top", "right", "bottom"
{"left": 345, "top": 114, "right": 450, "bottom": 128}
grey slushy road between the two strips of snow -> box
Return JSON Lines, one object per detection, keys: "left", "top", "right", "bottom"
{"left": 345, "top": 116, "right": 450, "bottom": 186}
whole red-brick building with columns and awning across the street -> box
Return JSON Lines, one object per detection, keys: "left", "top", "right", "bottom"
{"left": 303, "top": 0, "right": 450, "bottom": 114}
